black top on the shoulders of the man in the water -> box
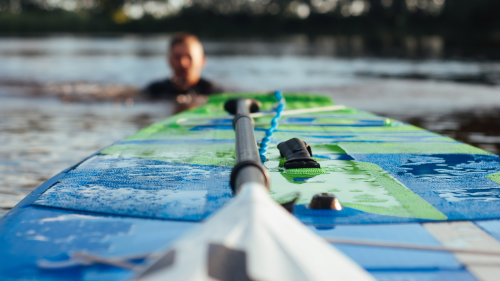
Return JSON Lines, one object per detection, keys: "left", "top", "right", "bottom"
{"left": 144, "top": 78, "right": 223, "bottom": 100}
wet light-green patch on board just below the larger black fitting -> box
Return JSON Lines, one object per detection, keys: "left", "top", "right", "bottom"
{"left": 266, "top": 160, "right": 447, "bottom": 220}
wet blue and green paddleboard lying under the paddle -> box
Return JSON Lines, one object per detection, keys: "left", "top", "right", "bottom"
{"left": 0, "top": 94, "right": 500, "bottom": 280}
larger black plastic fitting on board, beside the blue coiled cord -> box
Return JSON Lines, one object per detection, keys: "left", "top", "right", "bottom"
{"left": 278, "top": 138, "right": 321, "bottom": 169}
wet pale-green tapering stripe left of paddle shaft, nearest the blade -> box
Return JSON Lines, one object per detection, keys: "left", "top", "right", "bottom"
{"left": 101, "top": 143, "right": 235, "bottom": 167}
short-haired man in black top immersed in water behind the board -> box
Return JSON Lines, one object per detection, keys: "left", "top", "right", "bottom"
{"left": 144, "top": 33, "right": 223, "bottom": 108}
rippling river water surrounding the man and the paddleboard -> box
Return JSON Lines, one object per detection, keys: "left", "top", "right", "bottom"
{"left": 0, "top": 35, "right": 500, "bottom": 216}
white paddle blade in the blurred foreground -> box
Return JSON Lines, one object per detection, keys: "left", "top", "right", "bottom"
{"left": 137, "top": 183, "right": 375, "bottom": 281}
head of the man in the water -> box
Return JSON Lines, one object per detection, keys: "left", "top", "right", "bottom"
{"left": 168, "top": 33, "right": 207, "bottom": 88}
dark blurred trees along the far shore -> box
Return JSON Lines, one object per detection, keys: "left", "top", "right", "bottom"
{"left": 0, "top": 0, "right": 500, "bottom": 41}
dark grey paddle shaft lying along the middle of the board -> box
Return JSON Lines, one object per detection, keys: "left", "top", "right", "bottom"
{"left": 231, "top": 99, "right": 269, "bottom": 194}
